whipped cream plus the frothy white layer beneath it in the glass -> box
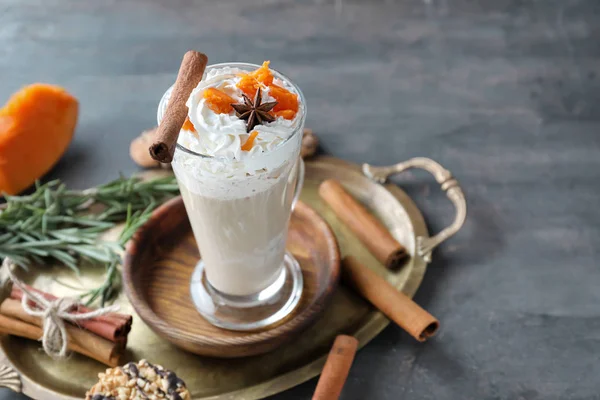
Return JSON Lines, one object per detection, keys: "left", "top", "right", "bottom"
{"left": 164, "top": 66, "right": 306, "bottom": 199}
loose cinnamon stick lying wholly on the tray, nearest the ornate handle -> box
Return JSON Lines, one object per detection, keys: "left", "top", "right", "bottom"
{"left": 319, "top": 179, "right": 408, "bottom": 269}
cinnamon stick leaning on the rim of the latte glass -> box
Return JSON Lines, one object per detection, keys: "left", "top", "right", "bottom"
{"left": 150, "top": 50, "right": 208, "bottom": 163}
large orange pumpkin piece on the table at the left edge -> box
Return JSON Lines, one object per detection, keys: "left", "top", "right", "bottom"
{"left": 0, "top": 83, "right": 79, "bottom": 194}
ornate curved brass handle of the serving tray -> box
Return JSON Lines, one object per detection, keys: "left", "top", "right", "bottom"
{"left": 362, "top": 157, "right": 467, "bottom": 262}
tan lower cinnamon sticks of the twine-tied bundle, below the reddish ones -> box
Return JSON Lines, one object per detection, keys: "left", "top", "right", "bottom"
{"left": 0, "top": 298, "right": 120, "bottom": 367}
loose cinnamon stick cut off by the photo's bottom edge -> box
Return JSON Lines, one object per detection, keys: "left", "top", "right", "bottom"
{"left": 312, "top": 335, "right": 358, "bottom": 400}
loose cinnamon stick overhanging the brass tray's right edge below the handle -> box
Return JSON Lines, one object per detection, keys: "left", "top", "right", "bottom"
{"left": 342, "top": 256, "right": 440, "bottom": 342}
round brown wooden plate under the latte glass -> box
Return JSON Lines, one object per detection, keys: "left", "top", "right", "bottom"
{"left": 123, "top": 197, "right": 340, "bottom": 358}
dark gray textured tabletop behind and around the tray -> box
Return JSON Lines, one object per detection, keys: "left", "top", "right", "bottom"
{"left": 0, "top": 0, "right": 600, "bottom": 400}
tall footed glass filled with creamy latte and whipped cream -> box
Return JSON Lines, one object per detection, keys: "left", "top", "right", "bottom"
{"left": 158, "top": 63, "right": 306, "bottom": 330}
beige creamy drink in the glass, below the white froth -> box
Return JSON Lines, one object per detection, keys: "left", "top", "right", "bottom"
{"left": 175, "top": 155, "right": 295, "bottom": 296}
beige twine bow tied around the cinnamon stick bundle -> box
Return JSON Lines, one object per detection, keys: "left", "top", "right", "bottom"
{"left": 2, "top": 257, "right": 119, "bottom": 359}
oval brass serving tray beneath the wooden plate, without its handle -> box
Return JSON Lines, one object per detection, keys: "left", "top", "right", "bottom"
{"left": 0, "top": 157, "right": 464, "bottom": 400}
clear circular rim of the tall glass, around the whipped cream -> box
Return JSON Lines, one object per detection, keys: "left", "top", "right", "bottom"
{"left": 157, "top": 62, "right": 306, "bottom": 162}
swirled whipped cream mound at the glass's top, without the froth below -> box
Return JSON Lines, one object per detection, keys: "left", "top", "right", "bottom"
{"left": 178, "top": 67, "right": 304, "bottom": 161}
